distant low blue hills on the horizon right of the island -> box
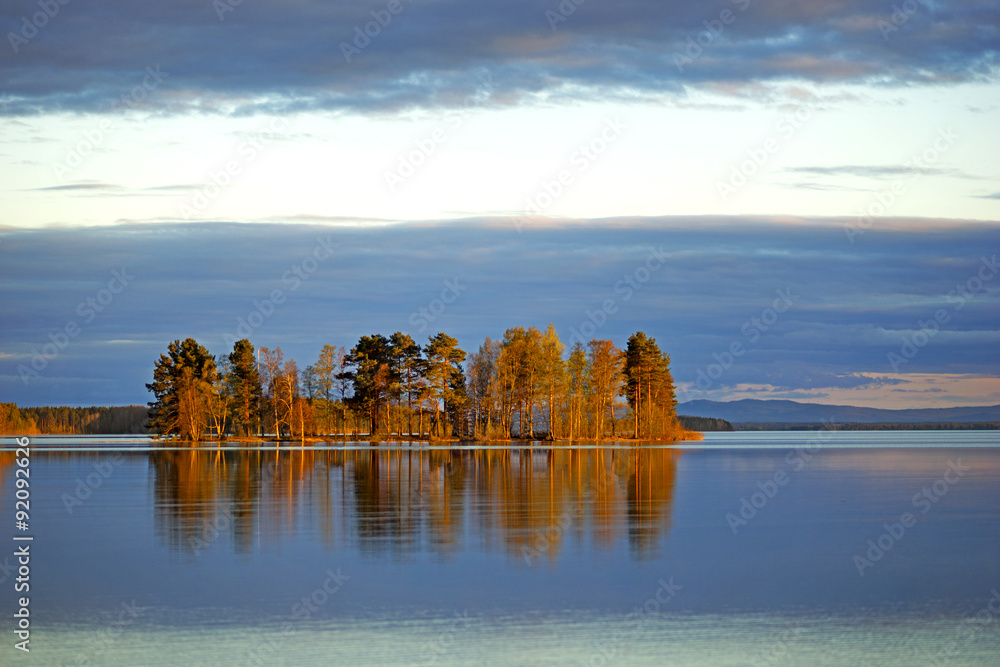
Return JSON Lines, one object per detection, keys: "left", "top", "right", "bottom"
{"left": 677, "top": 398, "right": 1000, "bottom": 424}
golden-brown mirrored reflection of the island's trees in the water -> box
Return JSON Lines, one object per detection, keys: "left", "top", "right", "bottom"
{"left": 150, "top": 447, "right": 681, "bottom": 565}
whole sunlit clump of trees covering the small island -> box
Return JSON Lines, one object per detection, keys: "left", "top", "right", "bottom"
{"left": 146, "top": 324, "right": 697, "bottom": 441}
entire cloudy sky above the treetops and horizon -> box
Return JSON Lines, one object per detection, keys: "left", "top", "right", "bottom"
{"left": 0, "top": 0, "right": 1000, "bottom": 407}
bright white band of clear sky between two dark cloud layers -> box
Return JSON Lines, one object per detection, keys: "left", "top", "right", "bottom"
{"left": 0, "top": 78, "right": 1000, "bottom": 227}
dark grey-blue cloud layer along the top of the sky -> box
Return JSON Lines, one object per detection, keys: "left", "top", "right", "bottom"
{"left": 0, "top": 0, "right": 1000, "bottom": 115}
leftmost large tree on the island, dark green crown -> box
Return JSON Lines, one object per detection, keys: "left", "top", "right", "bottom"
{"left": 146, "top": 338, "right": 216, "bottom": 442}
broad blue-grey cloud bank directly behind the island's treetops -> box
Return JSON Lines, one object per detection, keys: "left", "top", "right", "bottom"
{"left": 0, "top": 216, "right": 1000, "bottom": 404}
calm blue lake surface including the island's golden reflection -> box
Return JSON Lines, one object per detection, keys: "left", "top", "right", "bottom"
{"left": 0, "top": 431, "right": 1000, "bottom": 667}
